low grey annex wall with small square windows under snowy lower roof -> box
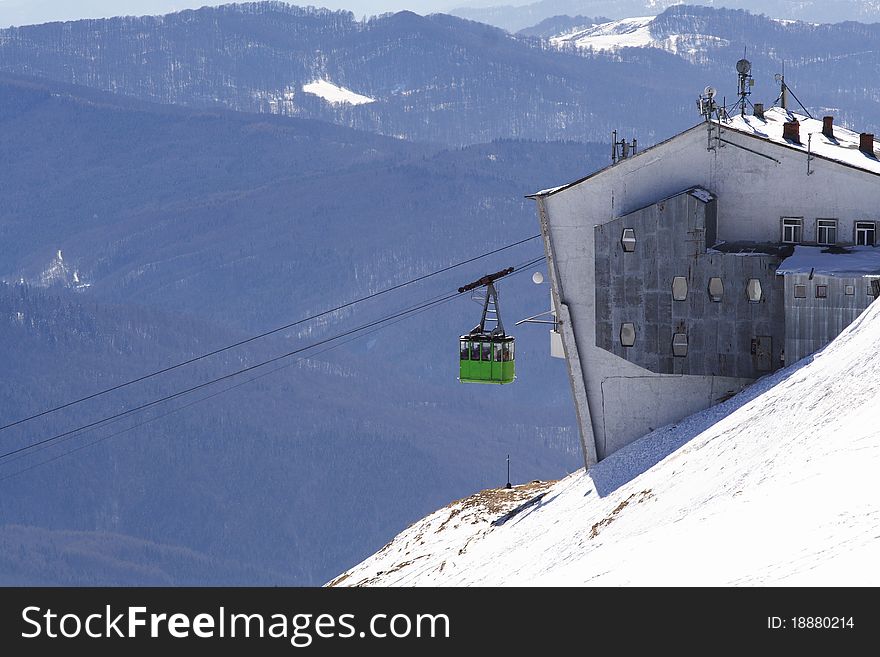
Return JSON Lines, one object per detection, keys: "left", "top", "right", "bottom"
{"left": 785, "top": 274, "right": 874, "bottom": 363}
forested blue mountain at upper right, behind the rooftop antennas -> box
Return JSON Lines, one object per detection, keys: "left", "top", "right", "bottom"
{"left": 558, "top": 6, "right": 880, "bottom": 132}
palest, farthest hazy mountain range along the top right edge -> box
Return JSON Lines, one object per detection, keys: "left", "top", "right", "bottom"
{"left": 449, "top": 0, "right": 880, "bottom": 32}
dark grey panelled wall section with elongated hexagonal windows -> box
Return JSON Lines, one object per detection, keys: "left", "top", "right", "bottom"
{"left": 594, "top": 188, "right": 785, "bottom": 380}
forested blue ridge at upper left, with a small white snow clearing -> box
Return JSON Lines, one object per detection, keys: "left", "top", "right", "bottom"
{"left": 0, "top": 2, "right": 705, "bottom": 145}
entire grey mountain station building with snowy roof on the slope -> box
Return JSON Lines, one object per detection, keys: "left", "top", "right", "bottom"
{"left": 530, "top": 105, "right": 880, "bottom": 467}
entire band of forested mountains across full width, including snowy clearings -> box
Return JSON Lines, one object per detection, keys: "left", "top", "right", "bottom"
{"left": 0, "top": 2, "right": 880, "bottom": 146}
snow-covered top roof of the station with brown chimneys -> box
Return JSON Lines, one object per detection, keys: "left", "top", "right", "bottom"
{"left": 720, "top": 107, "right": 880, "bottom": 174}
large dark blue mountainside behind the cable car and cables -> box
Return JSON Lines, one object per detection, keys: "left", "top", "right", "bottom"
{"left": 0, "top": 78, "right": 606, "bottom": 584}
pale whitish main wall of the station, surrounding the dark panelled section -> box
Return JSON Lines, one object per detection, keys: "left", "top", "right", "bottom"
{"left": 539, "top": 125, "right": 880, "bottom": 465}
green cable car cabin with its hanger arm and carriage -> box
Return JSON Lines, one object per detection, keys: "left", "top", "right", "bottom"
{"left": 458, "top": 267, "right": 516, "bottom": 384}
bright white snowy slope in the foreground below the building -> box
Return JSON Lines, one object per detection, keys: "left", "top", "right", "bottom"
{"left": 333, "top": 304, "right": 880, "bottom": 586}
